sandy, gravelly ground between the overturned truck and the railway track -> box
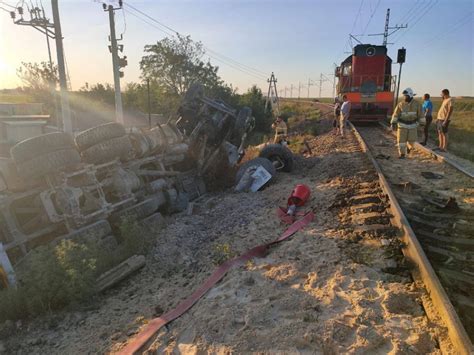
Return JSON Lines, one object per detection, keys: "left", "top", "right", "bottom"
{"left": 2, "top": 121, "right": 449, "bottom": 354}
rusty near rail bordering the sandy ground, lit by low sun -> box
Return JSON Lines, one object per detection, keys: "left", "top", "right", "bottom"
{"left": 349, "top": 122, "right": 474, "bottom": 354}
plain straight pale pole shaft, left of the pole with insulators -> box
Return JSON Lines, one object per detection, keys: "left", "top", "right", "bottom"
{"left": 51, "top": 0, "right": 72, "bottom": 133}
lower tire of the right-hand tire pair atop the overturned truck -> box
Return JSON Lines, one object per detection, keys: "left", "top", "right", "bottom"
{"left": 81, "top": 136, "right": 132, "bottom": 164}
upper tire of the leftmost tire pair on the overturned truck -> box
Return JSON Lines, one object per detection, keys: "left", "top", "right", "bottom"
{"left": 10, "top": 132, "right": 75, "bottom": 164}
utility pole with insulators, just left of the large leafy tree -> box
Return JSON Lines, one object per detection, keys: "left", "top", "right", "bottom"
{"left": 102, "top": 1, "right": 127, "bottom": 124}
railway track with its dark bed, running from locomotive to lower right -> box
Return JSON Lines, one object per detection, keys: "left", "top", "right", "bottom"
{"left": 344, "top": 121, "right": 474, "bottom": 353}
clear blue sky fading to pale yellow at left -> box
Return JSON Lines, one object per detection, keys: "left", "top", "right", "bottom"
{"left": 0, "top": 0, "right": 474, "bottom": 97}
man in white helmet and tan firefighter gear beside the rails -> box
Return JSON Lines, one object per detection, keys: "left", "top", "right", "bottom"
{"left": 390, "top": 88, "right": 422, "bottom": 159}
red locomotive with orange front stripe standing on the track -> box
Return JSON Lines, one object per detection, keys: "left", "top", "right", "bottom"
{"left": 336, "top": 44, "right": 395, "bottom": 122}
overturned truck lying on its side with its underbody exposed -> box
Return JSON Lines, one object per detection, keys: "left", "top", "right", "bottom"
{"left": 0, "top": 85, "right": 254, "bottom": 288}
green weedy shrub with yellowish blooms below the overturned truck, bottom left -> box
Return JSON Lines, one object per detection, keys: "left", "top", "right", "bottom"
{"left": 0, "top": 220, "right": 153, "bottom": 322}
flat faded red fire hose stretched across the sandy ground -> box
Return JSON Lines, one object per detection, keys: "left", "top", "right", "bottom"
{"left": 118, "top": 193, "right": 314, "bottom": 355}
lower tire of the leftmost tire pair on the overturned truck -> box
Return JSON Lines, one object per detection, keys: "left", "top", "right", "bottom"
{"left": 16, "top": 149, "right": 81, "bottom": 178}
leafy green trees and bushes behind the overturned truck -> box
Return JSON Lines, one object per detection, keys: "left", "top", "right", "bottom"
{"left": 17, "top": 35, "right": 272, "bottom": 132}
